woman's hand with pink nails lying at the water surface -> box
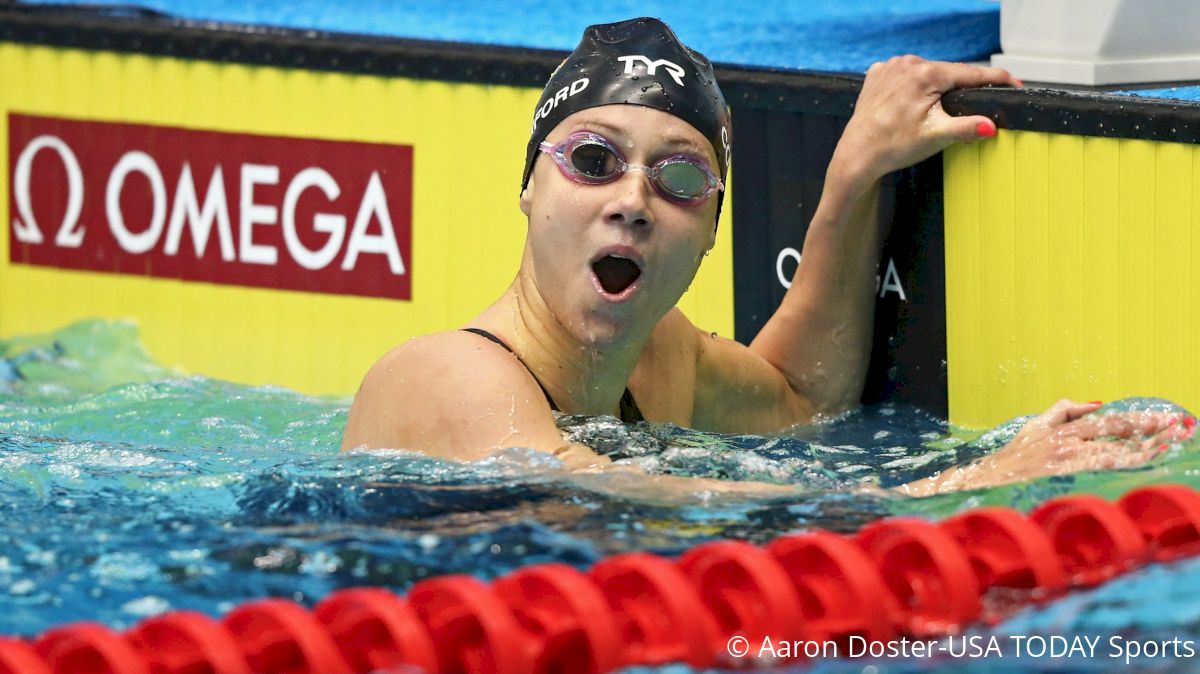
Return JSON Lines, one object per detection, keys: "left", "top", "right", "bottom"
{"left": 898, "top": 399, "right": 1196, "bottom": 495}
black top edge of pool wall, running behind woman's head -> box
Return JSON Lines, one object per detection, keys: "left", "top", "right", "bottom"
{"left": 0, "top": 2, "right": 1200, "bottom": 143}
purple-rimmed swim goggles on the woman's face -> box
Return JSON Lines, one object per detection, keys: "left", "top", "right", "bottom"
{"left": 538, "top": 131, "right": 725, "bottom": 205}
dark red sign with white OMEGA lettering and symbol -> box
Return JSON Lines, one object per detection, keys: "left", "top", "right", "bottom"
{"left": 8, "top": 114, "right": 413, "bottom": 300}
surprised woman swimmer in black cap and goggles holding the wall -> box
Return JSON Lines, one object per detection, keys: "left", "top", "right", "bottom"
{"left": 342, "top": 18, "right": 1192, "bottom": 494}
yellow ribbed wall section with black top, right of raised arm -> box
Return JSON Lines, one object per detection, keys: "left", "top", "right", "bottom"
{"left": 944, "top": 89, "right": 1200, "bottom": 426}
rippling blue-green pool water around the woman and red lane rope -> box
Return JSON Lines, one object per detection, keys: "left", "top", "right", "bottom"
{"left": 0, "top": 320, "right": 1200, "bottom": 673}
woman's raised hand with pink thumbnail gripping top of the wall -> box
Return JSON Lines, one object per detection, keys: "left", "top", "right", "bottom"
{"left": 830, "top": 55, "right": 1021, "bottom": 195}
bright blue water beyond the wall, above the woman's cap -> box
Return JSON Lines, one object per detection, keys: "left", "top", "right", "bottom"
{"left": 16, "top": 0, "right": 1000, "bottom": 72}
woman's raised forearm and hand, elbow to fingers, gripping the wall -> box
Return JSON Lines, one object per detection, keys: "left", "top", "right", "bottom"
{"left": 750, "top": 56, "right": 1019, "bottom": 413}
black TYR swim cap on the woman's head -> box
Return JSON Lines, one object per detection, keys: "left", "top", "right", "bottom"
{"left": 521, "top": 17, "right": 732, "bottom": 213}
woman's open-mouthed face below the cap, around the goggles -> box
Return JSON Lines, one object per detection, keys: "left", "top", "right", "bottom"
{"left": 521, "top": 104, "right": 718, "bottom": 347}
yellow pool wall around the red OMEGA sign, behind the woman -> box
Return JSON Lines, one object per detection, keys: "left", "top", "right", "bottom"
{"left": 0, "top": 43, "right": 733, "bottom": 395}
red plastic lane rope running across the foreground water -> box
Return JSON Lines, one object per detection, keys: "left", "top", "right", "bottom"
{"left": 0, "top": 485, "right": 1200, "bottom": 674}
